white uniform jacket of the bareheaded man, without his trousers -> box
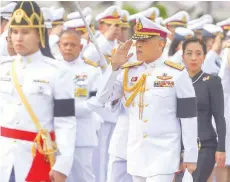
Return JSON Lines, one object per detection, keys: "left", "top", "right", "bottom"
{"left": 64, "top": 57, "right": 101, "bottom": 147}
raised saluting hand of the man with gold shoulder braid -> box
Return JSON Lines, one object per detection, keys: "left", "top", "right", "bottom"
{"left": 111, "top": 40, "right": 133, "bottom": 71}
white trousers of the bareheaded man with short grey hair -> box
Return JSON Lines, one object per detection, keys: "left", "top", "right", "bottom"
{"left": 67, "top": 147, "right": 95, "bottom": 182}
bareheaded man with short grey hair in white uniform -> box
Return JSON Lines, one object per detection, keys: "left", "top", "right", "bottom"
{"left": 59, "top": 30, "right": 100, "bottom": 182}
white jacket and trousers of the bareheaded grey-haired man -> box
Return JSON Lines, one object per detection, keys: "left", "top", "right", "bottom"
{"left": 65, "top": 57, "right": 100, "bottom": 182}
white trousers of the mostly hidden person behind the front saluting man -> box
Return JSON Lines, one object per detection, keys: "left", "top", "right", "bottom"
{"left": 107, "top": 155, "right": 133, "bottom": 182}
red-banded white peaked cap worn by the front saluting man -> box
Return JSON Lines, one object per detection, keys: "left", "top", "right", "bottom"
{"left": 132, "top": 16, "right": 171, "bottom": 40}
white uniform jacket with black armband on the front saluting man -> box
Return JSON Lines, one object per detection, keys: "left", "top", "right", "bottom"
{"left": 97, "top": 56, "right": 198, "bottom": 177}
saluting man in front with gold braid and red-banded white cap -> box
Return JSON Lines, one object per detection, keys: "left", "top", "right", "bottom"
{"left": 97, "top": 17, "right": 198, "bottom": 182}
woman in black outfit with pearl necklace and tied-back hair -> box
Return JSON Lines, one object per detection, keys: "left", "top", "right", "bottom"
{"left": 182, "top": 38, "right": 226, "bottom": 182}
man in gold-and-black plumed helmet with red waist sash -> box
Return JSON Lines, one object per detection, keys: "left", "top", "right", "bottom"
{"left": 0, "top": 1, "right": 76, "bottom": 182}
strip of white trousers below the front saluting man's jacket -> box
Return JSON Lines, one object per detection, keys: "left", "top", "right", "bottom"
{"left": 133, "top": 174, "right": 174, "bottom": 182}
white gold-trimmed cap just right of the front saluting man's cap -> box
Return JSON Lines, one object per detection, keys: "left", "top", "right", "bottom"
{"left": 162, "top": 11, "right": 190, "bottom": 26}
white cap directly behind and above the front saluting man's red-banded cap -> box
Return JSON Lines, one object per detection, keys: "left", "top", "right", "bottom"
{"left": 128, "top": 7, "right": 160, "bottom": 22}
